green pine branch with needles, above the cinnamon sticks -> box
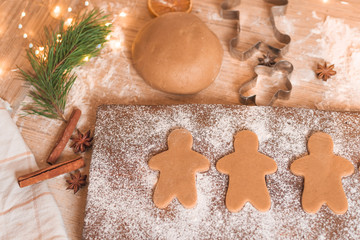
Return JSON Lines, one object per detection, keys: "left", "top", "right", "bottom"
{"left": 19, "top": 10, "right": 111, "bottom": 121}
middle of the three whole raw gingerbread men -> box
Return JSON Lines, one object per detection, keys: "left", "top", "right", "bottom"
{"left": 216, "top": 130, "right": 277, "bottom": 212}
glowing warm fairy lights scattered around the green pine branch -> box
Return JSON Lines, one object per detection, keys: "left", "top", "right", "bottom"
{"left": 0, "top": 1, "right": 129, "bottom": 76}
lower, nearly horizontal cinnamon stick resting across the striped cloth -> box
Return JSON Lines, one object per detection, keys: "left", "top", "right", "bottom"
{"left": 18, "top": 157, "right": 85, "bottom": 188}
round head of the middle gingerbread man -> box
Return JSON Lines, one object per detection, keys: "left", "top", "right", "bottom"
{"left": 234, "top": 130, "right": 259, "bottom": 152}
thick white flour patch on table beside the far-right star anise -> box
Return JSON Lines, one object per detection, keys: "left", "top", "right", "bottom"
{"left": 311, "top": 17, "right": 360, "bottom": 110}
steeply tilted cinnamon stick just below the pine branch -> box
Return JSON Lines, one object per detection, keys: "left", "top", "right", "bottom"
{"left": 46, "top": 109, "right": 81, "bottom": 164}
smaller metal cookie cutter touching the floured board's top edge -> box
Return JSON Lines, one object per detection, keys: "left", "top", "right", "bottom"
{"left": 239, "top": 60, "right": 294, "bottom": 105}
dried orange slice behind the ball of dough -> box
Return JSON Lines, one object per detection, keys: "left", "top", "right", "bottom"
{"left": 148, "top": 0, "right": 192, "bottom": 17}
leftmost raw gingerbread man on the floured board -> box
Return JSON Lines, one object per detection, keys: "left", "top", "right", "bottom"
{"left": 149, "top": 129, "right": 210, "bottom": 208}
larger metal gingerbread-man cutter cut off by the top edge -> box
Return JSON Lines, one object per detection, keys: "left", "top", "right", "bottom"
{"left": 220, "top": 0, "right": 291, "bottom": 61}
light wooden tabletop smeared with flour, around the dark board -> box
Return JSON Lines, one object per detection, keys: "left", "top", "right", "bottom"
{"left": 0, "top": 0, "right": 360, "bottom": 239}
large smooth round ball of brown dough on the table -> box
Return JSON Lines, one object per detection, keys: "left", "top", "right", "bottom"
{"left": 132, "top": 12, "right": 224, "bottom": 94}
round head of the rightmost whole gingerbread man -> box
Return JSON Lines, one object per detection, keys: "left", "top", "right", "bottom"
{"left": 308, "top": 132, "right": 334, "bottom": 154}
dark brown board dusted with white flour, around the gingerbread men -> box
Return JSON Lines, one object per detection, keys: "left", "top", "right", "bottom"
{"left": 83, "top": 105, "right": 360, "bottom": 239}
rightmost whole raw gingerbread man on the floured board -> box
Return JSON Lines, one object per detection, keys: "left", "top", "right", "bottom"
{"left": 290, "top": 132, "right": 354, "bottom": 214}
